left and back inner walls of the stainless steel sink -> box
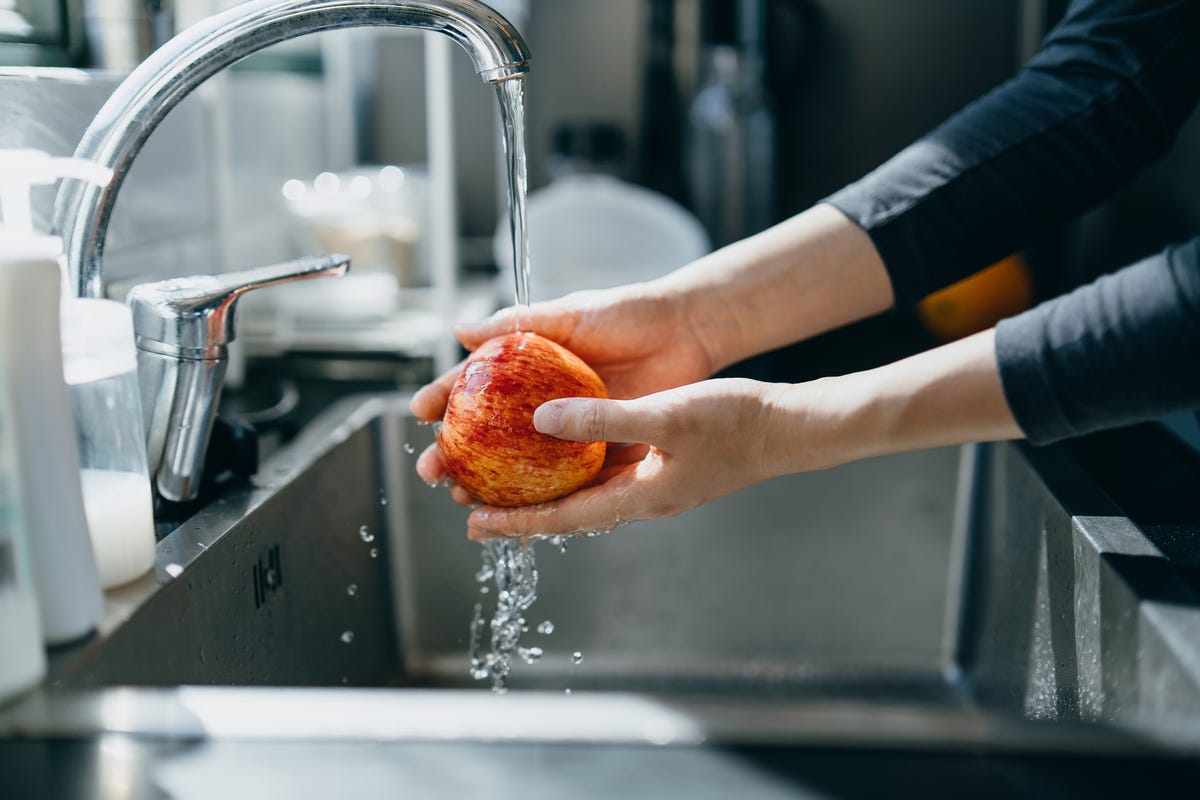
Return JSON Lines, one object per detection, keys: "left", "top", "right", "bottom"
{"left": 42, "top": 396, "right": 958, "bottom": 693}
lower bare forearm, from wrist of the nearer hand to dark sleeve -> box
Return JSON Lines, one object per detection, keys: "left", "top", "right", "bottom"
{"left": 764, "top": 330, "right": 1022, "bottom": 475}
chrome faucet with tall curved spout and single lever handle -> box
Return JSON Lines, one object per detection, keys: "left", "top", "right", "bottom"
{"left": 54, "top": 0, "right": 529, "bottom": 500}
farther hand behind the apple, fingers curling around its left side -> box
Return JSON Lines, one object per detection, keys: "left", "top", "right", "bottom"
{"left": 410, "top": 283, "right": 716, "bottom": 504}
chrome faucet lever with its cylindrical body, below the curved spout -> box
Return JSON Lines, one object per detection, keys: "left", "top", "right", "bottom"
{"left": 127, "top": 254, "right": 350, "bottom": 501}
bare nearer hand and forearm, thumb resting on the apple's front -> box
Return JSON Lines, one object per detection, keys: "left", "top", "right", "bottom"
{"left": 468, "top": 331, "right": 1021, "bottom": 539}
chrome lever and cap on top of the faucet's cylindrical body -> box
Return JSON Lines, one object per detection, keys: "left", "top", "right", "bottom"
{"left": 127, "top": 253, "right": 350, "bottom": 359}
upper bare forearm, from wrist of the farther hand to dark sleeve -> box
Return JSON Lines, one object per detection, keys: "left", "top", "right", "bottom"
{"left": 654, "top": 205, "right": 893, "bottom": 372}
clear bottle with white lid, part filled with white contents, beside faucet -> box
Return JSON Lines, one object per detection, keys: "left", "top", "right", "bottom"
{"left": 62, "top": 299, "right": 155, "bottom": 589}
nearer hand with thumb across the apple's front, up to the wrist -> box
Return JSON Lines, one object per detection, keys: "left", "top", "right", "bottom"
{"left": 453, "top": 379, "right": 785, "bottom": 540}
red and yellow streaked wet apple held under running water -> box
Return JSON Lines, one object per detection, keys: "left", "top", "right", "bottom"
{"left": 438, "top": 332, "right": 608, "bottom": 507}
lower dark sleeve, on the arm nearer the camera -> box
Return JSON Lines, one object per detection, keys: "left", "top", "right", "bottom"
{"left": 996, "top": 239, "right": 1200, "bottom": 444}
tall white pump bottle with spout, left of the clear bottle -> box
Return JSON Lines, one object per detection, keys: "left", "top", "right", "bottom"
{"left": 0, "top": 150, "right": 112, "bottom": 644}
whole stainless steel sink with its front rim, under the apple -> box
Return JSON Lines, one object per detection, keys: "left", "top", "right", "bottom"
{"left": 7, "top": 395, "right": 1200, "bottom": 753}
